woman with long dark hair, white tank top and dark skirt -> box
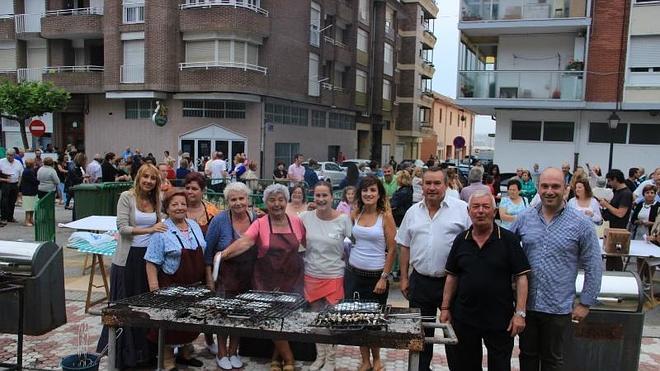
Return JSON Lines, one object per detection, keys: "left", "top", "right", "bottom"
{"left": 344, "top": 175, "right": 396, "bottom": 371}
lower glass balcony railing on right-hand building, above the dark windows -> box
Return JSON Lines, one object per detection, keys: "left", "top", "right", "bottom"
{"left": 458, "top": 71, "right": 584, "bottom": 100}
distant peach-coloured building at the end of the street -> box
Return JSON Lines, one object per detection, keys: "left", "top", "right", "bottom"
{"left": 420, "top": 92, "right": 476, "bottom": 161}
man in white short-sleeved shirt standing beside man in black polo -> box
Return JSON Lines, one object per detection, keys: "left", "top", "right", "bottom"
{"left": 396, "top": 168, "right": 472, "bottom": 371}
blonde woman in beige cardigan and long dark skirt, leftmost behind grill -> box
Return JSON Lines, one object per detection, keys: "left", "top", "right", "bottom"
{"left": 97, "top": 164, "right": 167, "bottom": 369}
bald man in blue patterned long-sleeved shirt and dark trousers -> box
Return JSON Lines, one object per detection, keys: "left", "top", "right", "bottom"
{"left": 511, "top": 168, "right": 603, "bottom": 371}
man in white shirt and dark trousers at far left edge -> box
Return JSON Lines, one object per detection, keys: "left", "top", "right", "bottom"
{"left": 0, "top": 148, "right": 23, "bottom": 226}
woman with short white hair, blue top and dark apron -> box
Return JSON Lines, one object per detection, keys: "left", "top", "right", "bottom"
{"left": 204, "top": 182, "right": 257, "bottom": 370}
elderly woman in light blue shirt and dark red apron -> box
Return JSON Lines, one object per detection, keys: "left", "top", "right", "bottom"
{"left": 143, "top": 190, "right": 206, "bottom": 370}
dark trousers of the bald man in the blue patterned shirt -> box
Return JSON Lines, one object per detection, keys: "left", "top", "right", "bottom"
{"left": 520, "top": 311, "right": 571, "bottom": 371}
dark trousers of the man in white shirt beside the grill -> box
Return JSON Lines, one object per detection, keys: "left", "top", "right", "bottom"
{"left": 408, "top": 269, "right": 445, "bottom": 371}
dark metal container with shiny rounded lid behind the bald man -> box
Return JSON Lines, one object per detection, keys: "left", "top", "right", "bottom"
{"left": 564, "top": 272, "right": 644, "bottom": 371}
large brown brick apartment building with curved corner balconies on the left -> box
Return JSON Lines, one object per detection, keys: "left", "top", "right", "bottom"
{"left": 0, "top": 0, "right": 437, "bottom": 176}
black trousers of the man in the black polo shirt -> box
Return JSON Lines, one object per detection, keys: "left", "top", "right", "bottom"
{"left": 447, "top": 320, "right": 513, "bottom": 371}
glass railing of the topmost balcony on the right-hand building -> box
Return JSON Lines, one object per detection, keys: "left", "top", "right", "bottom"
{"left": 461, "top": 0, "right": 587, "bottom": 21}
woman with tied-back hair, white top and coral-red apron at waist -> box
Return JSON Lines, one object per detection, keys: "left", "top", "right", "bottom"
{"left": 300, "top": 181, "right": 352, "bottom": 370}
